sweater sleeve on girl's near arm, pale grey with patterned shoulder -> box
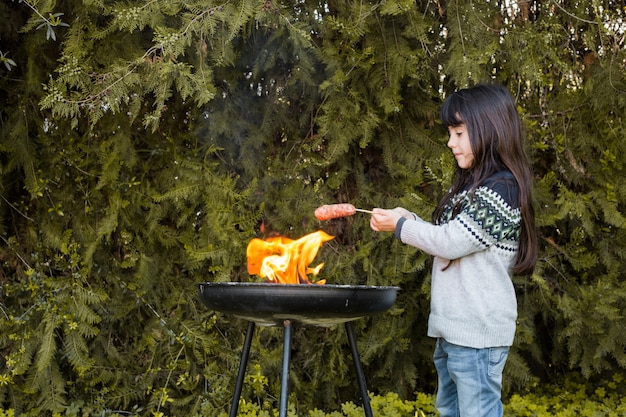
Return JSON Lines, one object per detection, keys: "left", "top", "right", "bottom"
{"left": 396, "top": 183, "right": 521, "bottom": 259}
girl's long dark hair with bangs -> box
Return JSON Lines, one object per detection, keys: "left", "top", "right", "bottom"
{"left": 433, "top": 84, "right": 537, "bottom": 275}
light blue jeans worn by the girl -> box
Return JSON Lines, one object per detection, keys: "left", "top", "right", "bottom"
{"left": 434, "top": 339, "right": 509, "bottom": 417}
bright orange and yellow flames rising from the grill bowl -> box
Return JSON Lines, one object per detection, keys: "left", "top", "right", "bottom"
{"left": 246, "top": 230, "right": 334, "bottom": 284}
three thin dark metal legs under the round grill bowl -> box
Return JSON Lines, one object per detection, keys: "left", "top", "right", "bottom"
{"left": 229, "top": 320, "right": 372, "bottom": 417}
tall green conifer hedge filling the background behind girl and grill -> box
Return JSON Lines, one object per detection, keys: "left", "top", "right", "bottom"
{"left": 0, "top": 0, "right": 626, "bottom": 416}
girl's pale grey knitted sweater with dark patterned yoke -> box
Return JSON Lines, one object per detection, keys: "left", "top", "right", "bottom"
{"left": 396, "top": 171, "right": 521, "bottom": 349}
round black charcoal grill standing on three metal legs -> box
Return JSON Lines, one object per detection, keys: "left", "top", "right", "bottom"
{"left": 197, "top": 282, "right": 398, "bottom": 417}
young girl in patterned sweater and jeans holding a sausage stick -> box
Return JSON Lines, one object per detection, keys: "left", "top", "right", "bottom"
{"left": 370, "top": 84, "right": 537, "bottom": 417}
